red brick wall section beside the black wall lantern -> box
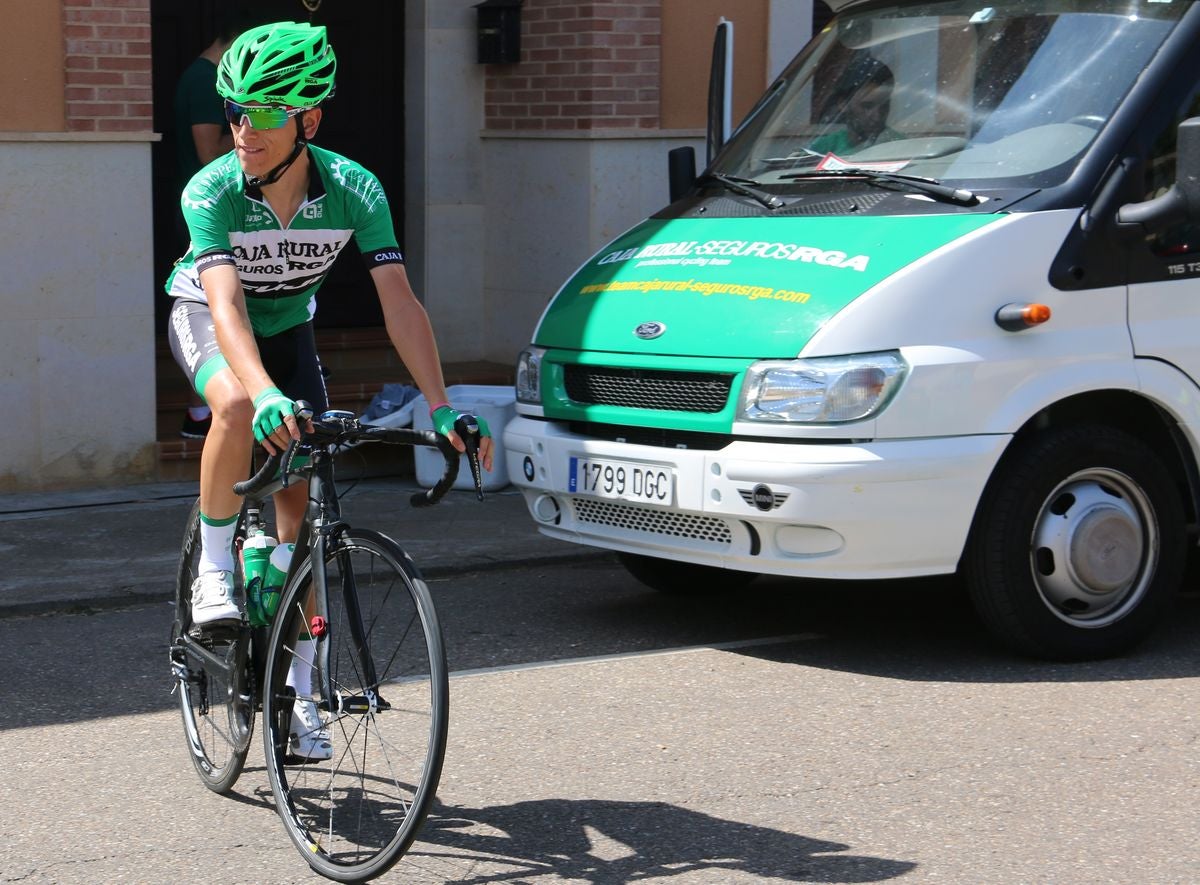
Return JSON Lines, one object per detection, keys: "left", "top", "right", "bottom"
{"left": 484, "top": 0, "right": 661, "bottom": 132}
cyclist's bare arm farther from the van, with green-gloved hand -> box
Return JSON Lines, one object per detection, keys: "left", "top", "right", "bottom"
{"left": 200, "top": 255, "right": 300, "bottom": 452}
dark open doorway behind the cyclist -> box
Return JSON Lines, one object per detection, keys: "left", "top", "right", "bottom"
{"left": 150, "top": 0, "right": 404, "bottom": 332}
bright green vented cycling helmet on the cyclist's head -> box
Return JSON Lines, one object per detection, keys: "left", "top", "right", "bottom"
{"left": 217, "top": 22, "right": 337, "bottom": 108}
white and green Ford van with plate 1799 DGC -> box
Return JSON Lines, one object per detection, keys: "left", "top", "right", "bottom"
{"left": 504, "top": 0, "right": 1200, "bottom": 660}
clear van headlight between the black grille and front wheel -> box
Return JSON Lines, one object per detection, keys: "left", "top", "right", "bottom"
{"left": 738, "top": 350, "right": 908, "bottom": 425}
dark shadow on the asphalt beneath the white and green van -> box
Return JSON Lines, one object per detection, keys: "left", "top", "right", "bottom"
{"left": 571, "top": 566, "right": 1200, "bottom": 684}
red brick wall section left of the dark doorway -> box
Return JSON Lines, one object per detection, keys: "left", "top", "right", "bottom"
{"left": 61, "top": 0, "right": 154, "bottom": 132}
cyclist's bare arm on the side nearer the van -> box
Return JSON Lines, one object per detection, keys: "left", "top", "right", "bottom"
{"left": 371, "top": 264, "right": 492, "bottom": 470}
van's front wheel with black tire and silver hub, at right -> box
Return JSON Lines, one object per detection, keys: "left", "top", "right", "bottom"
{"left": 964, "top": 425, "right": 1187, "bottom": 661}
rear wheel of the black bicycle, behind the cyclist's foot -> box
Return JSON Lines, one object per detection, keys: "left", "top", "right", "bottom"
{"left": 170, "top": 500, "right": 254, "bottom": 793}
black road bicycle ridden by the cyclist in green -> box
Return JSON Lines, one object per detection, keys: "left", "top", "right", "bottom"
{"left": 170, "top": 403, "right": 484, "bottom": 881}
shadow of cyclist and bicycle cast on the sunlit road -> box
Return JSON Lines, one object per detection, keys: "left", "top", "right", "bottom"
{"left": 406, "top": 799, "right": 917, "bottom": 885}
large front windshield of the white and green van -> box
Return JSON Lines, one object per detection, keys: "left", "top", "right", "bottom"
{"left": 710, "top": 0, "right": 1190, "bottom": 187}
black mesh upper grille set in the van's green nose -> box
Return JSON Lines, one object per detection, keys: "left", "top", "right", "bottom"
{"left": 563, "top": 365, "right": 733, "bottom": 414}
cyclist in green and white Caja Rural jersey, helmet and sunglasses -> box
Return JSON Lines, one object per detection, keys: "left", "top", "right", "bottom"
{"left": 167, "top": 22, "right": 493, "bottom": 759}
